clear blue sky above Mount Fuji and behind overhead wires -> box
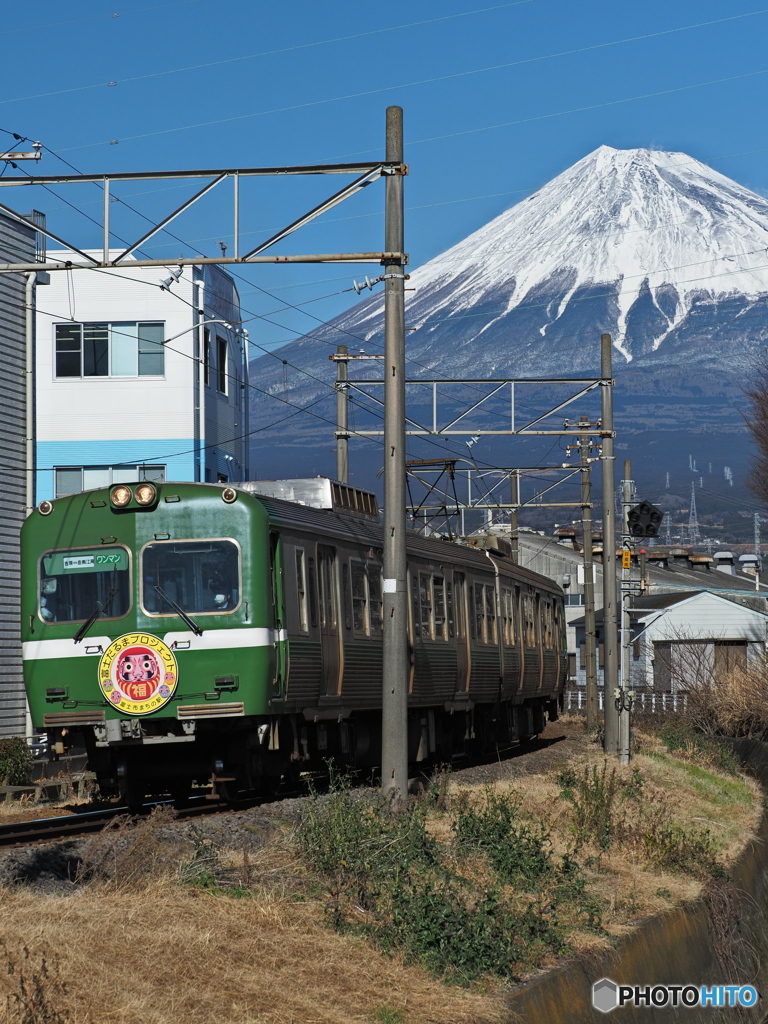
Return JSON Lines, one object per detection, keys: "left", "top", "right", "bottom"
{"left": 0, "top": 0, "right": 768, "bottom": 347}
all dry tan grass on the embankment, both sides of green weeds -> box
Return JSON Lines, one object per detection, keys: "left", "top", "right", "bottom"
{"left": 0, "top": 735, "right": 762, "bottom": 1024}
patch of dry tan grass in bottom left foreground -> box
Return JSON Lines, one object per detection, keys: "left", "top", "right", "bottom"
{"left": 0, "top": 879, "right": 501, "bottom": 1024}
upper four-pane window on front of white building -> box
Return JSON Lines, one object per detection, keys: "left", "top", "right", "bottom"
{"left": 54, "top": 321, "right": 165, "bottom": 377}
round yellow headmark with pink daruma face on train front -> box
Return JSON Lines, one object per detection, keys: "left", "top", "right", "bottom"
{"left": 98, "top": 633, "right": 178, "bottom": 715}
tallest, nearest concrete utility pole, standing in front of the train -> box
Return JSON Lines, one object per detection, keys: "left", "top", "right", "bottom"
{"left": 381, "top": 106, "right": 409, "bottom": 800}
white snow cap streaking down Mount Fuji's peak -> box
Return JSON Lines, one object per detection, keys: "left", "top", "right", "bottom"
{"left": 357, "top": 145, "right": 768, "bottom": 361}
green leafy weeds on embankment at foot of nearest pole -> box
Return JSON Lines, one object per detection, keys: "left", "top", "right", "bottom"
{"left": 295, "top": 786, "right": 600, "bottom": 984}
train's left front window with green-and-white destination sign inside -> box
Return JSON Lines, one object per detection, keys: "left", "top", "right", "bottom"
{"left": 38, "top": 547, "right": 131, "bottom": 623}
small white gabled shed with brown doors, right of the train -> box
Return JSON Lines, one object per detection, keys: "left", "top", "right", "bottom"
{"left": 573, "top": 590, "right": 768, "bottom": 693}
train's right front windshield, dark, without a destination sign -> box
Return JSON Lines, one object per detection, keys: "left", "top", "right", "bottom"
{"left": 141, "top": 541, "right": 241, "bottom": 615}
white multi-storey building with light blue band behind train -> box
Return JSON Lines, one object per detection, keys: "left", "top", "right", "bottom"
{"left": 36, "top": 251, "right": 249, "bottom": 502}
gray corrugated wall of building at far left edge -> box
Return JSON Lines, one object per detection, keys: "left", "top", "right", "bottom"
{"left": 0, "top": 215, "right": 35, "bottom": 736}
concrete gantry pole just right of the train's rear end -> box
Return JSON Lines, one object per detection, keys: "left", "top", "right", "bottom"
{"left": 600, "top": 334, "right": 618, "bottom": 754}
